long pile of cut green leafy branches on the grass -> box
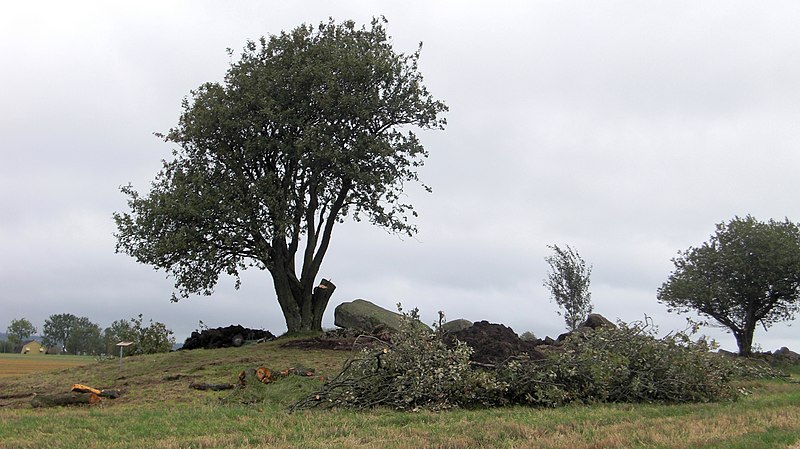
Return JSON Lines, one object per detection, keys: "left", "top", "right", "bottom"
{"left": 292, "top": 310, "right": 779, "bottom": 410}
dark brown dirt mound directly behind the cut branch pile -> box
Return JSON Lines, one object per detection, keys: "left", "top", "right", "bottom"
{"left": 445, "top": 321, "right": 544, "bottom": 364}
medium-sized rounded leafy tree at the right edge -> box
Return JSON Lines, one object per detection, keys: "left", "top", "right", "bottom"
{"left": 658, "top": 215, "right": 800, "bottom": 355}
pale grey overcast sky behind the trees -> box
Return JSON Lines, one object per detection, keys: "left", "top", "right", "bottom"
{"left": 0, "top": 0, "right": 800, "bottom": 350}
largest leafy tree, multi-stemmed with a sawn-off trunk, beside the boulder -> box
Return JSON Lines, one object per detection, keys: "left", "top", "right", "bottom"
{"left": 114, "top": 19, "right": 447, "bottom": 333}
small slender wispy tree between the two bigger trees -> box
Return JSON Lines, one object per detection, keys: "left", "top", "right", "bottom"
{"left": 544, "top": 245, "right": 592, "bottom": 330}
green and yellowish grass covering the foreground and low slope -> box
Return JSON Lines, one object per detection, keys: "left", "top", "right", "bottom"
{"left": 0, "top": 342, "right": 800, "bottom": 449}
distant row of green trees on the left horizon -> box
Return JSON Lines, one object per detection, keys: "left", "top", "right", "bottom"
{"left": 0, "top": 313, "right": 175, "bottom": 355}
